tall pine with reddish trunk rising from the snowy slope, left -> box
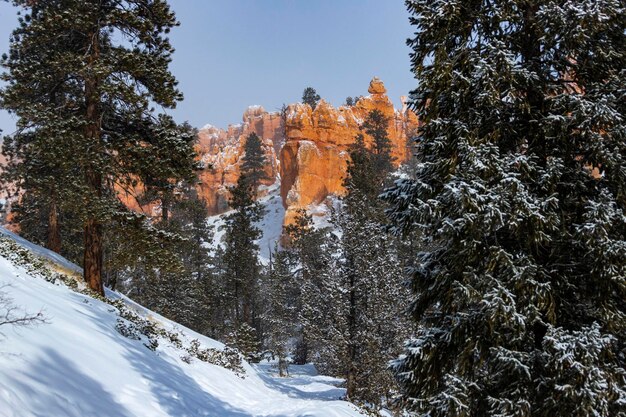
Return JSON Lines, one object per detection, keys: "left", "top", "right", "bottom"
{"left": 0, "top": 0, "right": 193, "bottom": 294}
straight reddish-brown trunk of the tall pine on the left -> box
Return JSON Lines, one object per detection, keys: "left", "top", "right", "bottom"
{"left": 83, "top": 29, "right": 104, "bottom": 295}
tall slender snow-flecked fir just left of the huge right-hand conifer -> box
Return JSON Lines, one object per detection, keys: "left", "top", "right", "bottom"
{"left": 328, "top": 133, "right": 409, "bottom": 406}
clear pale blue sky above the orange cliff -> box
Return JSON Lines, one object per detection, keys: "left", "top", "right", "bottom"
{"left": 0, "top": 0, "right": 415, "bottom": 134}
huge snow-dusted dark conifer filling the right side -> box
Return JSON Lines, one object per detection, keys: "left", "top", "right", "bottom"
{"left": 386, "top": 0, "right": 626, "bottom": 417}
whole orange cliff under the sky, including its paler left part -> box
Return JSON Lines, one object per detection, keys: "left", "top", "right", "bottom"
{"left": 197, "top": 78, "right": 417, "bottom": 223}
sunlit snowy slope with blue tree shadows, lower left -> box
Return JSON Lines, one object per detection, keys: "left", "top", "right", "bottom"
{"left": 0, "top": 229, "right": 360, "bottom": 417}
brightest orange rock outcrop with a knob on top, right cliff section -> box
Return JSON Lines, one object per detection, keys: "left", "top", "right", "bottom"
{"left": 279, "top": 78, "right": 417, "bottom": 223}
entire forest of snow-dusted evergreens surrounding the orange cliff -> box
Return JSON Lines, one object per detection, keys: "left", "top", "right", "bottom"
{"left": 0, "top": 0, "right": 626, "bottom": 417}
